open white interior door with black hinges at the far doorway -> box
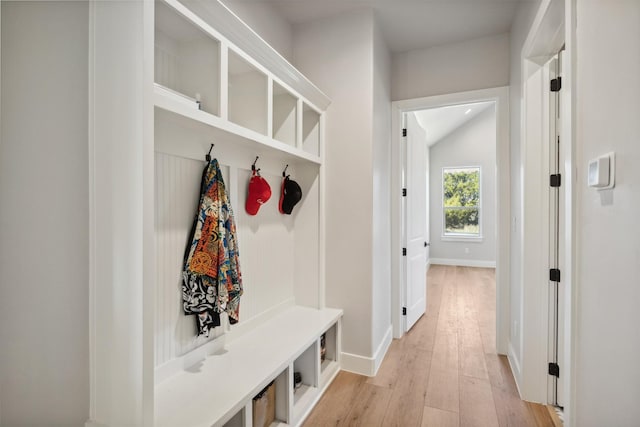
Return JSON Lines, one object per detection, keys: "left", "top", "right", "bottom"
{"left": 404, "top": 113, "right": 429, "bottom": 331}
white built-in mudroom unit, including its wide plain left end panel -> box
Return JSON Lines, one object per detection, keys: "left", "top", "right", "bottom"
{"left": 87, "top": 0, "right": 342, "bottom": 427}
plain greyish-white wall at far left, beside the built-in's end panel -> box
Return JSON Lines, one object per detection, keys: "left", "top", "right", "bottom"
{"left": 0, "top": 1, "right": 89, "bottom": 426}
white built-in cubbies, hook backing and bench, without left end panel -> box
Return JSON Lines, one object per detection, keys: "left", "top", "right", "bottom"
{"left": 153, "top": 0, "right": 342, "bottom": 427}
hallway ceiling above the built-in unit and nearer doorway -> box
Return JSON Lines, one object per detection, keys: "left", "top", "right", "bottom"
{"left": 230, "top": 0, "right": 533, "bottom": 52}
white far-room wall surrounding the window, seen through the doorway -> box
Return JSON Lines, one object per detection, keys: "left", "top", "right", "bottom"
{"left": 429, "top": 106, "right": 496, "bottom": 266}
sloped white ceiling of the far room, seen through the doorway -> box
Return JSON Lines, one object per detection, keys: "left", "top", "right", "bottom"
{"left": 415, "top": 102, "right": 495, "bottom": 146}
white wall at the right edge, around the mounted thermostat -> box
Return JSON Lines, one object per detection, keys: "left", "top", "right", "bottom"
{"left": 573, "top": 0, "right": 640, "bottom": 427}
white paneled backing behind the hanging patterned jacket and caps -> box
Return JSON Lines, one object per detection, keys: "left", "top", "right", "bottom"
{"left": 155, "top": 152, "right": 295, "bottom": 367}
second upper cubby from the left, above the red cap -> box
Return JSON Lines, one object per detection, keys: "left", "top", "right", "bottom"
{"left": 228, "top": 49, "right": 268, "bottom": 135}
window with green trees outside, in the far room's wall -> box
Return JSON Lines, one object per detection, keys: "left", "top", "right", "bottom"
{"left": 442, "top": 166, "right": 480, "bottom": 237}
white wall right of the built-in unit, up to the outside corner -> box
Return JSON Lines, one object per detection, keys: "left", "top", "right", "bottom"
{"left": 293, "top": 10, "right": 374, "bottom": 368}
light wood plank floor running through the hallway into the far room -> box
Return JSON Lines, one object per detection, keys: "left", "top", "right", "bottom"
{"left": 304, "top": 266, "right": 554, "bottom": 427}
